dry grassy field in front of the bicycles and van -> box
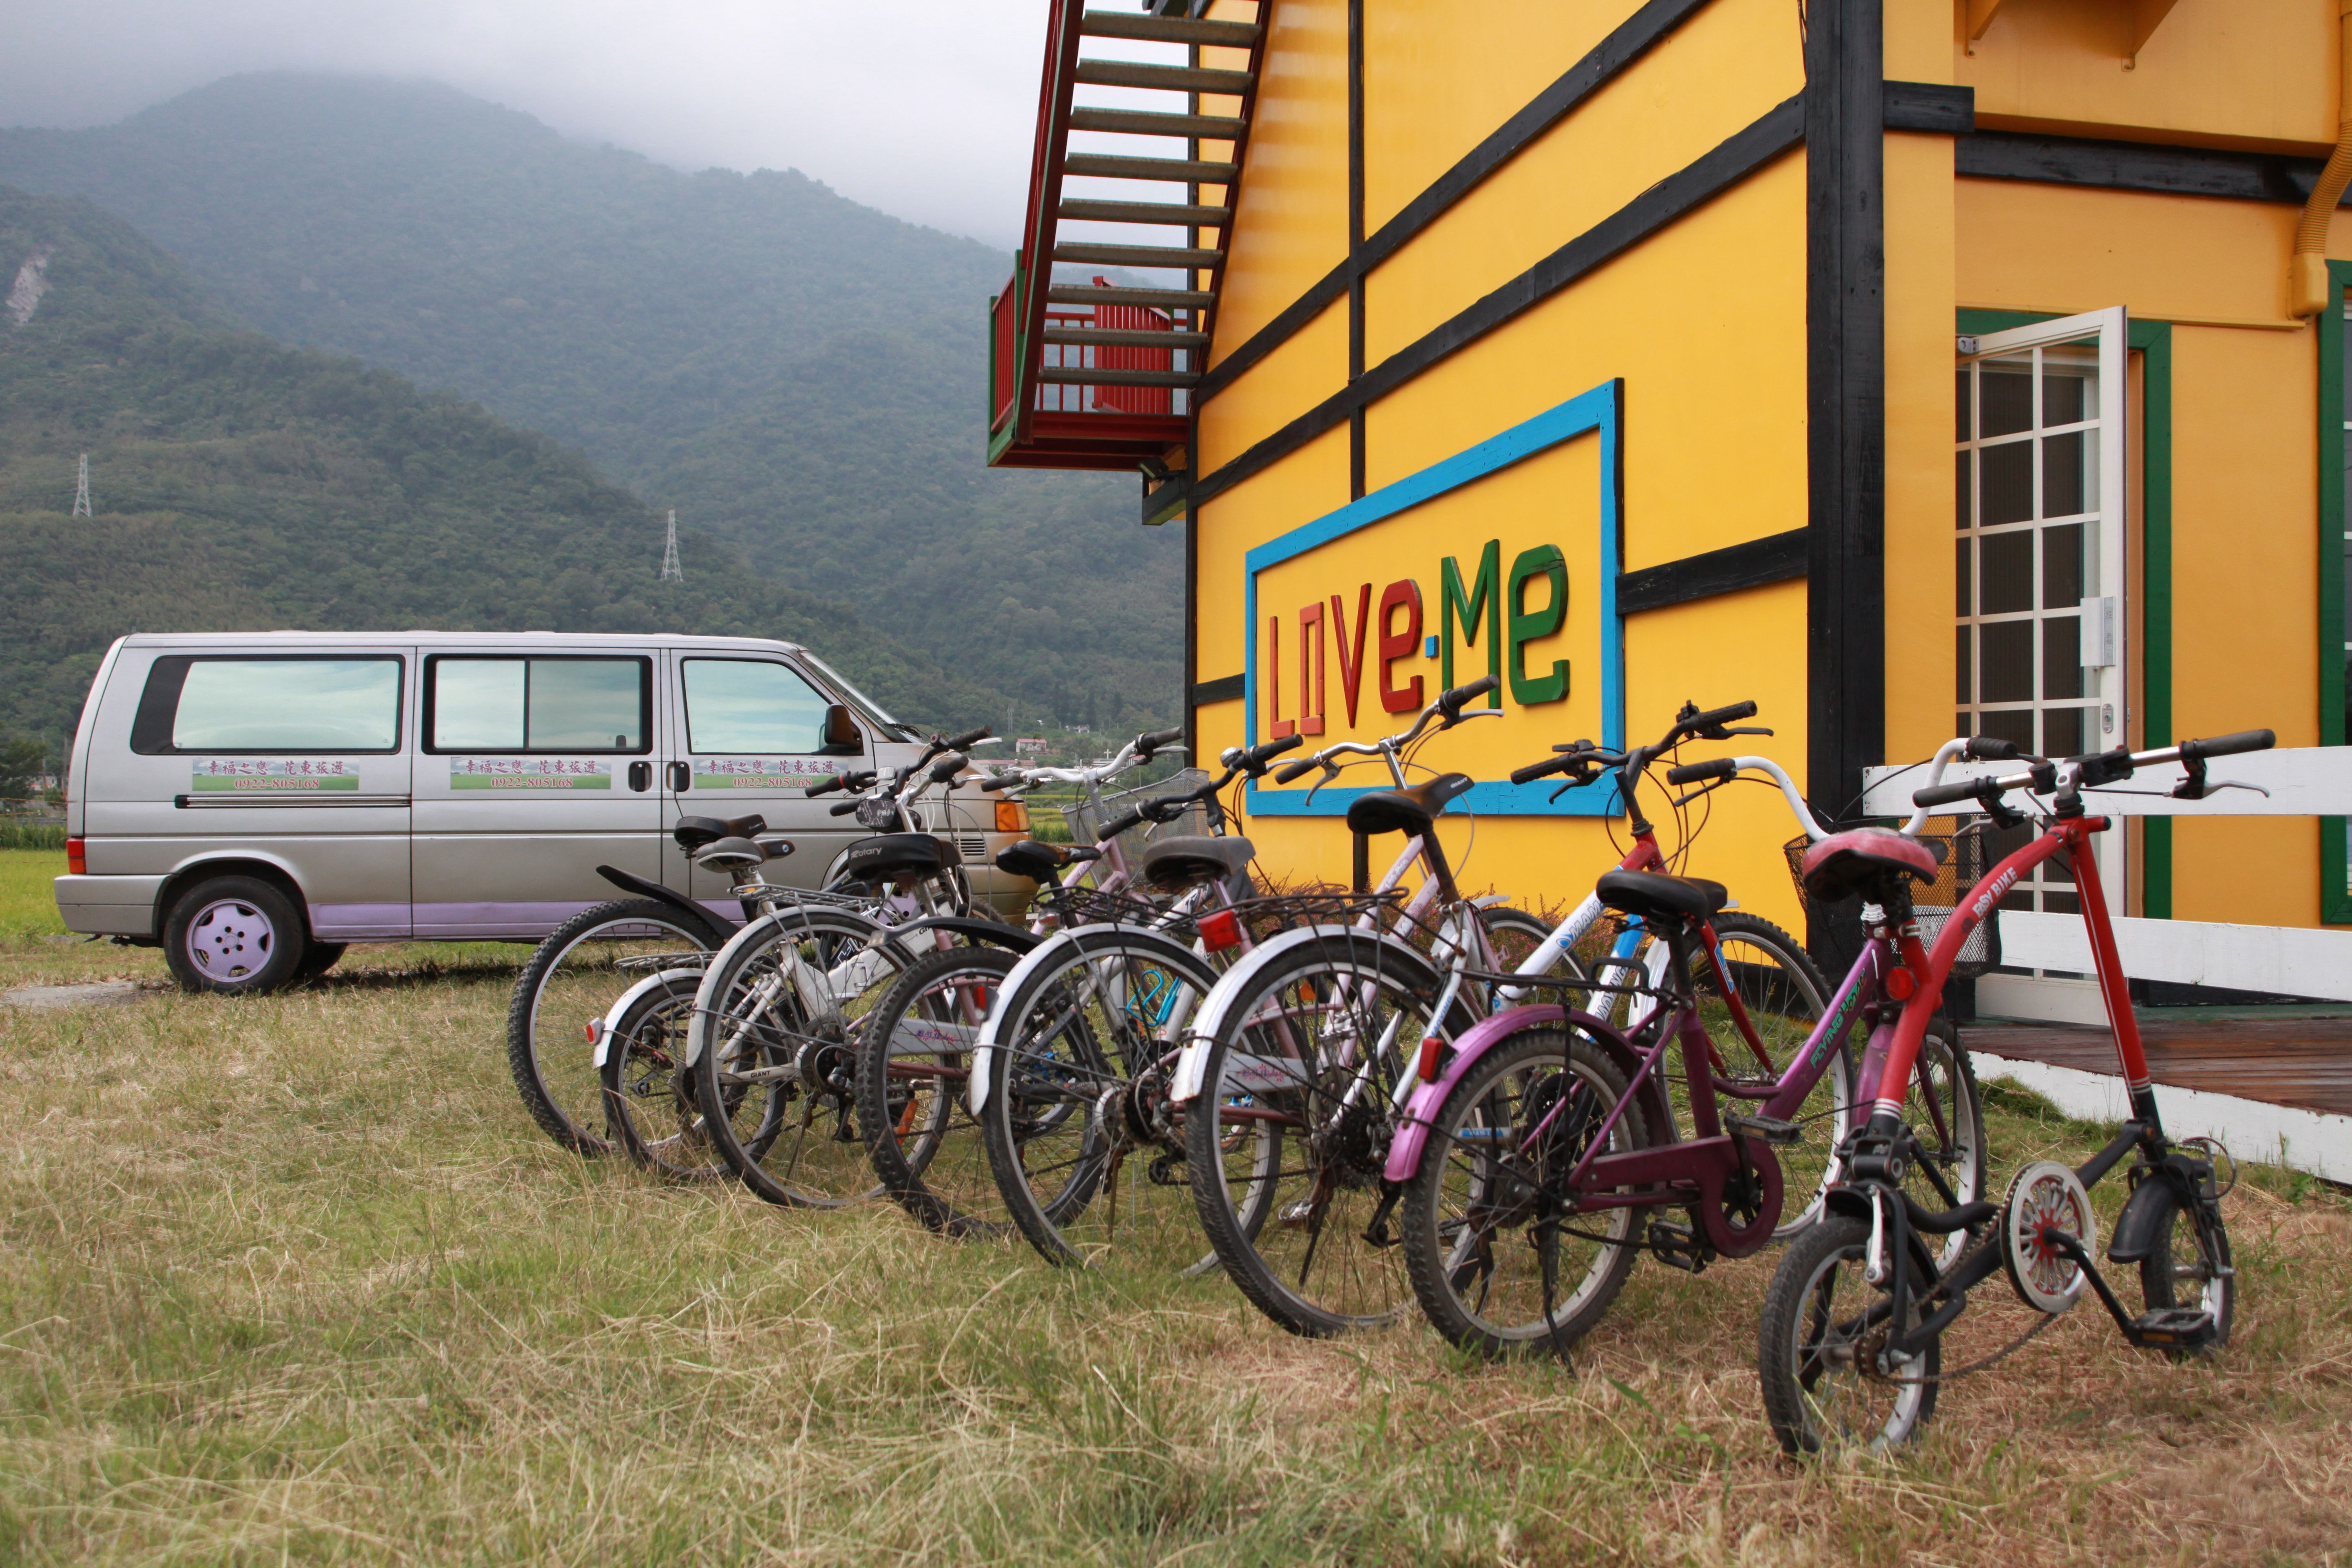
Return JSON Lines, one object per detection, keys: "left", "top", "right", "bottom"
{"left": 0, "top": 854, "right": 2352, "bottom": 1568}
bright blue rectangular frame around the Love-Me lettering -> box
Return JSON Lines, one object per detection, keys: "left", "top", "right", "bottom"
{"left": 1242, "top": 379, "right": 1625, "bottom": 816}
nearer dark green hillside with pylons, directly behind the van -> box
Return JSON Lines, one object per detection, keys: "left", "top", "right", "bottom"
{"left": 0, "top": 186, "right": 997, "bottom": 740}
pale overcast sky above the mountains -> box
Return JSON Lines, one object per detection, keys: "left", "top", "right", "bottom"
{"left": 0, "top": 0, "right": 1063, "bottom": 249}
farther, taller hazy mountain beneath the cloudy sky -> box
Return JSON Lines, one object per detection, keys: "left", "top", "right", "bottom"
{"left": 0, "top": 75, "right": 1183, "bottom": 726}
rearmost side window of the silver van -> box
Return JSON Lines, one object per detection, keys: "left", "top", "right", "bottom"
{"left": 132, "top": 653, "right": 400, "bottom": 757}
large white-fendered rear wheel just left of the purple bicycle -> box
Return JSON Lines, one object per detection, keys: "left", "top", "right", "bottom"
{"left": 1185, "top": 931, "right": 1470, "bottom": 1335}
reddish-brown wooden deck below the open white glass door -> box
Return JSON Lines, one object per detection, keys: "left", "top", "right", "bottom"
{"left": 1959, "top": 1008, "right": 2352, "bottom": 1117}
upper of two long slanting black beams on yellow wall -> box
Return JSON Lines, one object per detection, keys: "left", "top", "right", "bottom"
{"left": 1192, "top": 0, "right": 1707, "bottom": 402}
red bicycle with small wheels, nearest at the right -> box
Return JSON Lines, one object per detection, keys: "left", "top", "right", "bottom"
{"left": 1757, "top": 729, "right": 2277, "bottom": 1453}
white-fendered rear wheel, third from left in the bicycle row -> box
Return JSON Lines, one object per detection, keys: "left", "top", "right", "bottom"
{"left": 687, "top": 905, "right": 913, "bottom": 1208}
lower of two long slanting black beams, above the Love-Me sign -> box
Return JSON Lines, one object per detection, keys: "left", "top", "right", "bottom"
{"left": 1192, "top": 99, "right": 1804, "bottom": 505}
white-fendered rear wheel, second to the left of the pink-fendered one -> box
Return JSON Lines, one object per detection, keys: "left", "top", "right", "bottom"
{"left": 981, "top": 926, "right": 1216, "bottom": 1265}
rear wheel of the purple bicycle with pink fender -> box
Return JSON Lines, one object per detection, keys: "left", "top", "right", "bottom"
{"left": 1397, "top": 1027, "right": 1649, "bottom": 1357}
